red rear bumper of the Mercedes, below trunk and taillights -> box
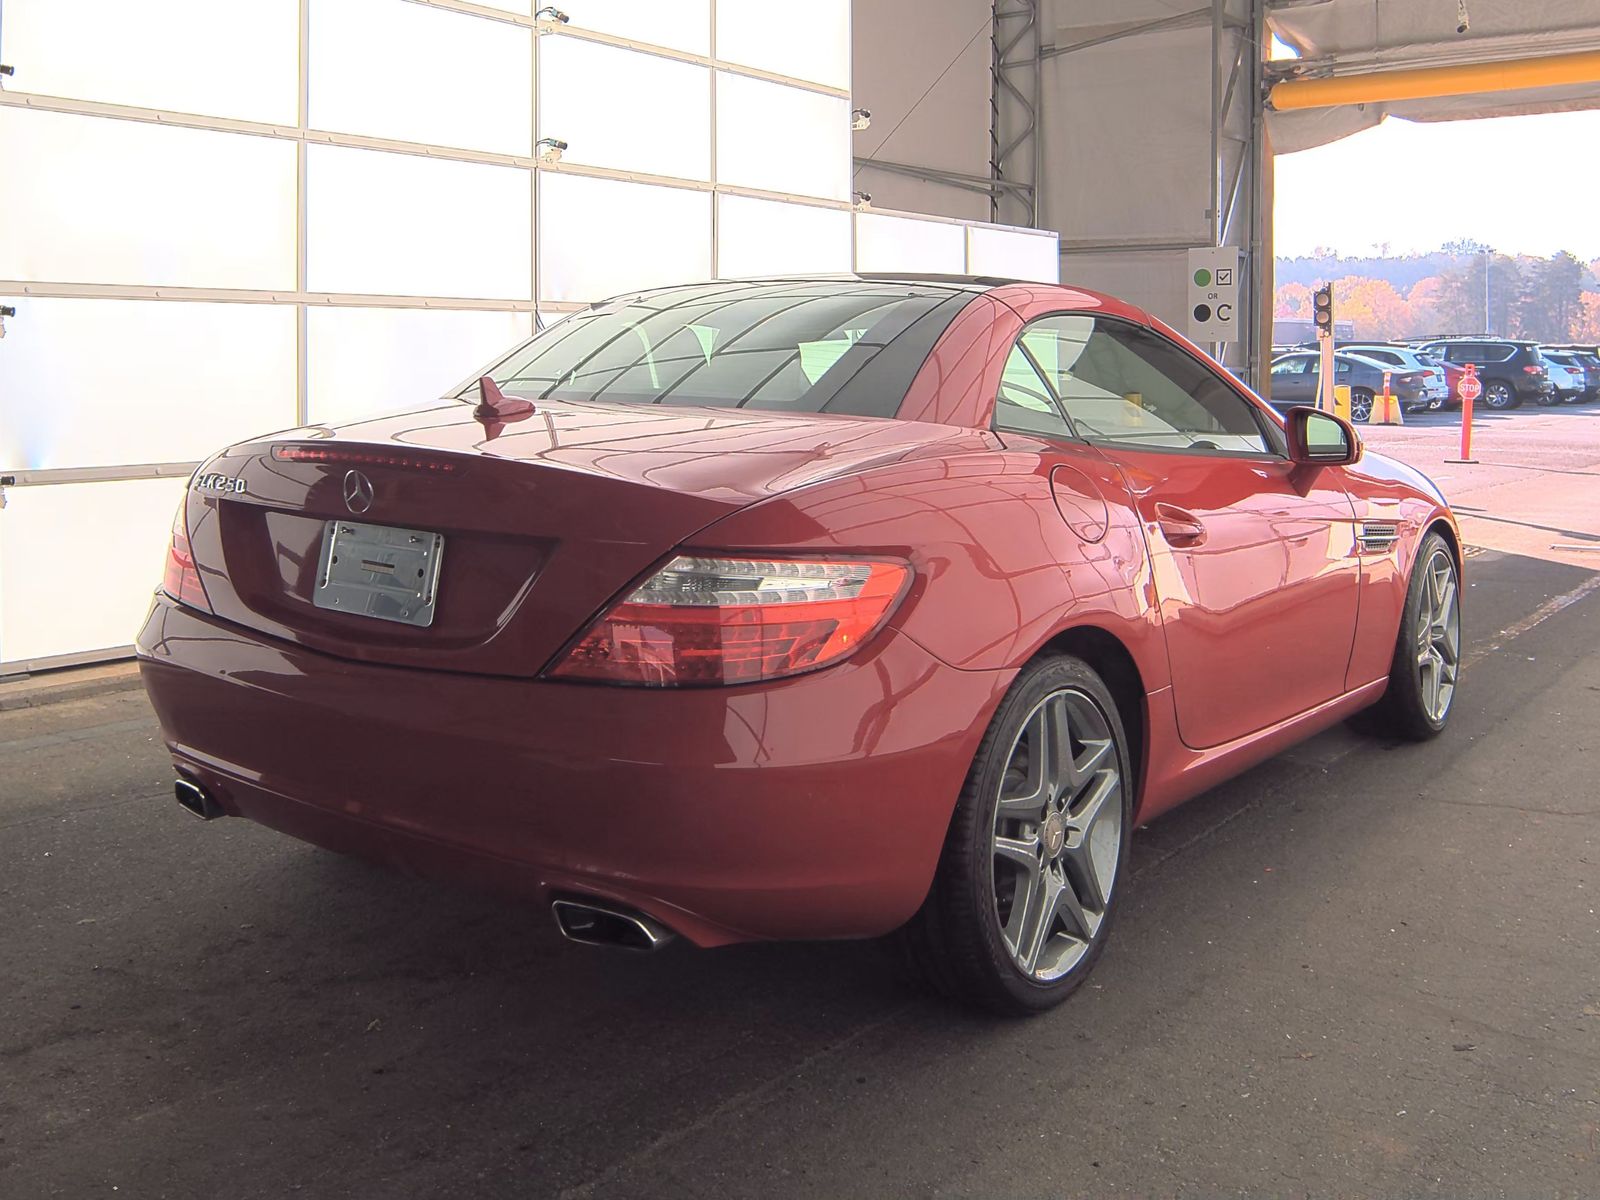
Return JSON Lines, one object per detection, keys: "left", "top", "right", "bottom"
{"left": 138, "top": 597, "right": 1011, "bottom": 946}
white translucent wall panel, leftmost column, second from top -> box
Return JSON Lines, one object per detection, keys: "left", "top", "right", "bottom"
{"left": 0, "top": 107, "right": 294, "bottom": 290}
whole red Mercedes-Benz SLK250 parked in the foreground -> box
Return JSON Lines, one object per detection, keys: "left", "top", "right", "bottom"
{"left": 139, "top": 277, "right": 1461, "bottom": 1011}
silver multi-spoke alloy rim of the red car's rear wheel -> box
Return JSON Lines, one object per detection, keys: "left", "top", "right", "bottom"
{"left": 990, "top": 688, "right": 1125, "bottom": 982}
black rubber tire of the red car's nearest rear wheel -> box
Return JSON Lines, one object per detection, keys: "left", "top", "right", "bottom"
{"left": 891, "top": 656, "right": 1134, "bottom": 1016}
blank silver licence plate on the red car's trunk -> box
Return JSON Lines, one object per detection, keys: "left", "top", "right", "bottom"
{"left": 312, "top": 520, "right": 445, "bottom": 627}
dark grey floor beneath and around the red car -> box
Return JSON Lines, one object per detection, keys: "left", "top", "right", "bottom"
{"left": 0, "top": 413, "right": 1600, "bottom": 1198}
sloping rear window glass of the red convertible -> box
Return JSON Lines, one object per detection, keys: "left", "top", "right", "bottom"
{"left": 462, "top": 282, "right": 971, "bottom": 416}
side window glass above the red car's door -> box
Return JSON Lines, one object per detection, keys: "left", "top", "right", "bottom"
{"left": 1021, "top": 314, "right": 1275, "bottom": 454}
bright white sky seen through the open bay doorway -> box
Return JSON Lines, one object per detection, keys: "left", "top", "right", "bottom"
{"left": 1274, "top": 112, "right": 1600, "bottom": 262}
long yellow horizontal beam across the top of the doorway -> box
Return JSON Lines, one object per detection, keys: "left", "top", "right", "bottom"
{"left": 1269, "top": 50, "right": 1600, "bottom": 112}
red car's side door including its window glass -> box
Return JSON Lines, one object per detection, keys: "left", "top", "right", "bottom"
{"left": 997, "top": 320, "right": 1360, "bottom": 749}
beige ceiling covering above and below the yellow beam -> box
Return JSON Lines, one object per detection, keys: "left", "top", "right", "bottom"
{"left": 1267, "top": 0, "right": 1600, "bottom": 154}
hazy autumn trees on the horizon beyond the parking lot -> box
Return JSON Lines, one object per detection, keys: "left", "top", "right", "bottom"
{"left": 1274, "top": 242, "right": 1600, "bottom": 342}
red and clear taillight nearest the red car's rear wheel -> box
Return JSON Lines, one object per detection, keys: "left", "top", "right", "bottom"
{"left": 550, "top": 555, "right": 910, "bottom": 688}
